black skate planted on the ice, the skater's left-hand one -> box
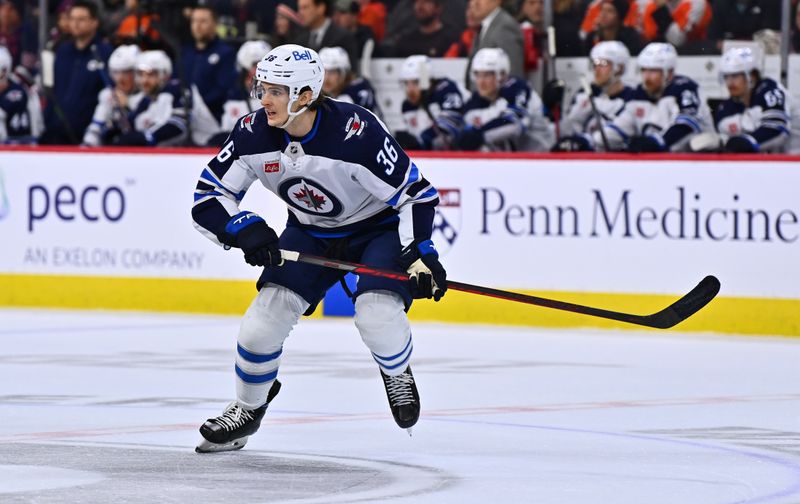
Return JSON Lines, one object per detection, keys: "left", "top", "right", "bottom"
{"left": 194, "top": 380, "right": 281, "bottom": 453}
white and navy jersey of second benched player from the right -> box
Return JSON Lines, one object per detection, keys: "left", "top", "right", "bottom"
{"left": 592, "top": 76, "right": 712, "bottom": 152}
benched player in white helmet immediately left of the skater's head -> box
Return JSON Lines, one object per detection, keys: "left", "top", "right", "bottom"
{"left": 208, "top": 40, "right": 272, "bottom": 147}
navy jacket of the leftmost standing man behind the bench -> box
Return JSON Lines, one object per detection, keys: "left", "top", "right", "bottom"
{"left": 45, "top": 37, "right": 112, "bottom": 143}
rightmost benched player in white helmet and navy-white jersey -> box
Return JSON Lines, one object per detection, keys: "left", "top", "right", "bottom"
{"left": 714, "top": 47, "right": 800, "bottom": 154}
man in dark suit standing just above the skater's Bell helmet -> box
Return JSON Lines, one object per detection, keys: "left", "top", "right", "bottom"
{"left": 295, "top": 0, "right": 361, "bottom": 65}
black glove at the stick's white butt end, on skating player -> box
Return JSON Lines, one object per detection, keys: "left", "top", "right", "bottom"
{"left": 220, "top": 212, "right": 283, "bottom": 266}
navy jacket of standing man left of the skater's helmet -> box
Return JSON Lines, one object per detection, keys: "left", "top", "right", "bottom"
{"left": 181, "top": 38, "right": 237, "bottom": 121}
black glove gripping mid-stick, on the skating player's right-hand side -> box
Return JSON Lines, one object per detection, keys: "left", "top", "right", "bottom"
{"left": 400, "top": 240, "right": 447, "bottom": 301}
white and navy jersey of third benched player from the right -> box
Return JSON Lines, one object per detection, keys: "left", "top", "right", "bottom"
{"left": 561, "top": 84, "right": 633, "bottom": 136}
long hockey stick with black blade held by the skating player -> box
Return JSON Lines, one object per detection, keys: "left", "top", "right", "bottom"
{"left": 281, "top": 250, "right": 720, "bottom": 329}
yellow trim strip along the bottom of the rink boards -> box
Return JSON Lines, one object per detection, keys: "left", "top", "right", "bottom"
{"left": 0, "top": 275, "right": 800, "bottom": 336}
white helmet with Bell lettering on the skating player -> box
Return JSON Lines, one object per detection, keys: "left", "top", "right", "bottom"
{"left": 251, "top": 44, "right": 325, "bottom": 128}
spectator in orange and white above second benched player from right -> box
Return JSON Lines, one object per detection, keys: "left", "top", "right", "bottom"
{"left": 642, "top": 0, "right": 711, "bottom": 48}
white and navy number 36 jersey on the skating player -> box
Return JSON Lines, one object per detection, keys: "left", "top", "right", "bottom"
{"left": 192, "top": 99, "right": 439, "bottom": 246}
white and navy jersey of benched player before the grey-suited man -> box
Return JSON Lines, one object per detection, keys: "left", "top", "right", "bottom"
{"left": 464, "top": 77, "right": 555, "bottom": 152}
